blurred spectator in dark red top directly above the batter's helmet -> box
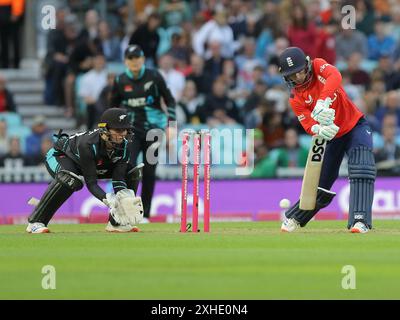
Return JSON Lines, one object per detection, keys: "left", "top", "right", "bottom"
{"left": 287, "top": 3, "right": 318, "bottom": 59}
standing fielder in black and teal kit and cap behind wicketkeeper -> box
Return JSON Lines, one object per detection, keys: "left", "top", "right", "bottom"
{"left": 110, "top": 45, "right": 175, "bottom": 219}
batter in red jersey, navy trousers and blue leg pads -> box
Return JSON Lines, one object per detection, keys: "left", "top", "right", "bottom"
{"left": 279, "top": 47, "right": 376, "bottom": 233}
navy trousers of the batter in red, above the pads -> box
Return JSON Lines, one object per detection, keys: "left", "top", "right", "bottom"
{"left": 319, "top": 118, "right": 372, "bottom": 190}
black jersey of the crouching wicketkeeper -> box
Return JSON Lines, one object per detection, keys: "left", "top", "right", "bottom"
{"left": 61, "top": 129, "right": 132, "bottom": 200}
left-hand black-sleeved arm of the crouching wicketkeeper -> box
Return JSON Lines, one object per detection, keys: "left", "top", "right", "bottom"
{"left": 78, "top": 144, "right": 106, "bottom": 201}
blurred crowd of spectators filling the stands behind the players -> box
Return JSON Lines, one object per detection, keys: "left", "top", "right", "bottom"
{"left": 0, "top": 0, "right": 400, "bottom": 177}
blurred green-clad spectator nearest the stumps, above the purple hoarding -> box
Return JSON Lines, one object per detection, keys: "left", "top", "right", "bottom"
{"left": 250, "top": 129, "right": 276, "bottom": 178}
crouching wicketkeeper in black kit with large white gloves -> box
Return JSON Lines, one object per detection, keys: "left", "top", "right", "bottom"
{"left": 26, "top": 108, "right": 143, "bottom": 233}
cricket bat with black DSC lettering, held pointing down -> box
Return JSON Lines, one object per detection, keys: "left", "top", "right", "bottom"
{"left": 299, "top": 135, "right": 327, "bottom": 210}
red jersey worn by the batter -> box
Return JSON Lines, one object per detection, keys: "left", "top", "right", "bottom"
{"left": 289, "top": 58, "right": 363, "bottom": 138}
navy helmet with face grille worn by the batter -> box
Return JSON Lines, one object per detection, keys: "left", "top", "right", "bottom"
{"left": 279, "top": 47, "right": 312, "bottom": 89}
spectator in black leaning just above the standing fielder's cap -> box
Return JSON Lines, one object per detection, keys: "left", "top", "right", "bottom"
{"left": 129, "top": 12, "right": 161, "bottom": 67}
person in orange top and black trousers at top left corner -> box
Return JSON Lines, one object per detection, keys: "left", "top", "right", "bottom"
{"left": 0, "top": 0, "right": 25, "bottom": 69}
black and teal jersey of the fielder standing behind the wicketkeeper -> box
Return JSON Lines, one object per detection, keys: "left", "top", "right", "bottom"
{"left": 110, "top": 66, "right": 175, "bottom": 133}
